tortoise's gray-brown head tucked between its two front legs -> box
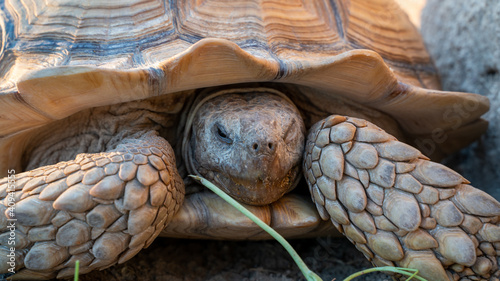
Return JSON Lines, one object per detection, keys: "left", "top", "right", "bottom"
{"left": 188, "top": 89, "right": 305, "bottom": 205}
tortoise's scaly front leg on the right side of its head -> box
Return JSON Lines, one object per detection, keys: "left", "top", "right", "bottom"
{"left": 303, "top": 116, "right": 500, "bottom": 281}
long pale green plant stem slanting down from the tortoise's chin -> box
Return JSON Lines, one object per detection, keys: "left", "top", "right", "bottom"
{"left": 190, "top": 176, "right": 322, "bottom": 281}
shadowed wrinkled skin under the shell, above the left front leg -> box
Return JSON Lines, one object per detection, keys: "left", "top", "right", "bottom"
{"left": 22, "top": 92, "right": 190, "bottom": 171}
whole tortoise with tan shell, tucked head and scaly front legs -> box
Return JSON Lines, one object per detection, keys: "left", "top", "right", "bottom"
{"left": 0, "top": 0, "right": 500, "bottom": 280}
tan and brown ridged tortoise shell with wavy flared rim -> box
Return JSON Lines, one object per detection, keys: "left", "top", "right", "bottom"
{"left": 0, "top": 0, "right": 488, "bottom": 173}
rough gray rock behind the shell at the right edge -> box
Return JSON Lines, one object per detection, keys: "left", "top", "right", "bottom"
{"left": 421, "top": 0, "right": 500, "bottom": 199}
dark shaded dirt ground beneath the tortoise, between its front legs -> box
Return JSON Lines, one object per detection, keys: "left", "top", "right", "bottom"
{"left": 80, "top": 237, "right": 392, "bottom": 281}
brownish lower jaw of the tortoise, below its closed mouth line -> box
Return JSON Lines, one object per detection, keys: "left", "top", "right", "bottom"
{"left": 208, "top": 165, "right": 300, "bottom": 206}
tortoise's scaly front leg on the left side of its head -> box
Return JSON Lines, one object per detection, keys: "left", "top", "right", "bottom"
{"left": 0, "top": 132, "right": 184, "bottom": 279}
